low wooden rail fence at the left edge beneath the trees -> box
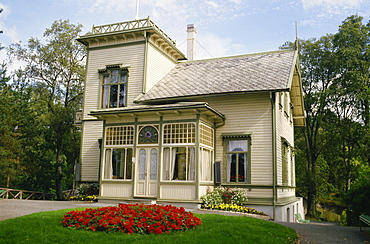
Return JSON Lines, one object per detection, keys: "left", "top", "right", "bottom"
{"left": 0, "top": 187, "right": 73, "bottom": 200}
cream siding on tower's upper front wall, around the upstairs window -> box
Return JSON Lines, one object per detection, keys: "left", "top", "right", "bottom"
{"left": 83, "top": 43, "right": 145, "bottom": 120}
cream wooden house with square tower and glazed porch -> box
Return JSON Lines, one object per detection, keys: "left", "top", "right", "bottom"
{"left": 78, "top": 18, "right": 305, "bottom": 221}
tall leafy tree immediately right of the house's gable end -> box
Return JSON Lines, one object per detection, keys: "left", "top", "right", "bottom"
{"left": 282, "top": 35, "right": 336, "bottom": 216}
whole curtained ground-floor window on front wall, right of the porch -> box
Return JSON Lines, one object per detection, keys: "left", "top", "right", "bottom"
{"left": 223, "top": 135, "right": 250, "bottom": 183}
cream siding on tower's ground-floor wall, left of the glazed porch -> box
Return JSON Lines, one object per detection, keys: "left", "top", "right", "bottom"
{"left": 81, "top": 121, "right": 103, "bottom": 181}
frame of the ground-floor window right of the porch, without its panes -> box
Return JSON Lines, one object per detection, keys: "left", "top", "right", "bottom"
{"left": 221, "top": 134, "right": 252, "bottom": 185}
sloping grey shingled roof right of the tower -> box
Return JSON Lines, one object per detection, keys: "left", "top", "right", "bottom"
{"left": 136, "top": 50, "right": 296, "bottom": 102}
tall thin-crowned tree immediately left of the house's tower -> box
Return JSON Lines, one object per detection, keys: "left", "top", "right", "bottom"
{"left": 9, "top": 20, "right": 86, "bottom": 200}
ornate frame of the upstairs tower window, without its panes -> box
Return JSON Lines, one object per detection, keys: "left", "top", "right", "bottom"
{"left": 98, "top": 64, "right": 129, "bottom": 109}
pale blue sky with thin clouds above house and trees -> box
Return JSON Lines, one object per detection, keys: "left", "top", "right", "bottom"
{"left": 0, "top": 0, "right": 370, "bottom": 61}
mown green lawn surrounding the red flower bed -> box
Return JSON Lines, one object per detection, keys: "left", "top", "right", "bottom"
{"left": 0, "top": 209, "right": 297, "bottom": 244}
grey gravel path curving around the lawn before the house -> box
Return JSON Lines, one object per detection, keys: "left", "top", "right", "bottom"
{"left": 0, "top": 199, "right": 370, "bottom": 244}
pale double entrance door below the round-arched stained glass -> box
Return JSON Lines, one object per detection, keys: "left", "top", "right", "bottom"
{"left": 136, "top": 147, "right": 158, "bottom": 197}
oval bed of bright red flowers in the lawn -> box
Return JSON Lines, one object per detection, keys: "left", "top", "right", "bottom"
{"left": 61, "top": 204, "right": 201, "bottom": 234}
